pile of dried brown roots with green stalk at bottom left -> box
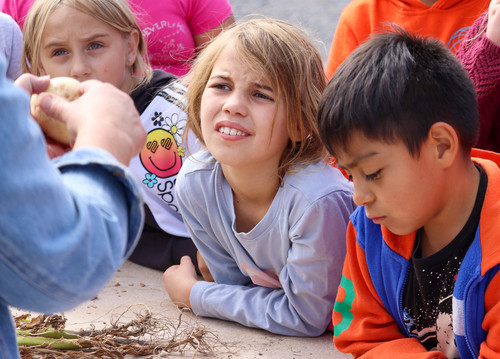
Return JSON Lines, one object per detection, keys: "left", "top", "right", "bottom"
{"left": 14, "top": 307, "right": 231, "bottom": 359}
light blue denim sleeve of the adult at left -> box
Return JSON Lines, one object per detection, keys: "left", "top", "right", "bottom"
{"left": 0, "top": 59, "right": 143, "bottom": 312}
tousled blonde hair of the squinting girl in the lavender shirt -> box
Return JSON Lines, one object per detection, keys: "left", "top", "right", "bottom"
{"left": 184, "top": 19, "right": 326, "bottom": 181}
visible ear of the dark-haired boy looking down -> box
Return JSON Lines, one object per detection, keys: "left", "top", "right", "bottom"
{"left": 427, "top": 122, "right": 460, "bottom": 168}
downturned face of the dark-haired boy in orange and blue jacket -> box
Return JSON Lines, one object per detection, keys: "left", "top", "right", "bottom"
{"left": 337, "top": 134, "right": 443, "bottom": 235}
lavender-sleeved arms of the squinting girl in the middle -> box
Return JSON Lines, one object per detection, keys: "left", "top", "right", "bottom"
{"left": 183, "top": 192, "right": 352, "bottom": 336}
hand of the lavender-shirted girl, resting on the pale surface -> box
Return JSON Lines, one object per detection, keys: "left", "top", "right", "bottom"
{"left": 163, "top": 256, "right": 198, "bottom": 309}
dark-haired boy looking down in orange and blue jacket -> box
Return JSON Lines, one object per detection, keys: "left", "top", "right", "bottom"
{"left": 318, "top": 28, "right": 500, "bottom": 359}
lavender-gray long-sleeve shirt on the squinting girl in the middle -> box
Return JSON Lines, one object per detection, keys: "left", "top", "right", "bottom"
{"left": 176, "top": 151, "right": 355, "bottom": 336}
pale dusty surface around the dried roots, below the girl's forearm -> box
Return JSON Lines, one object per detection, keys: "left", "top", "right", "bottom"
{"left": 13, "top": 262, "right": 351, "bottom": 359}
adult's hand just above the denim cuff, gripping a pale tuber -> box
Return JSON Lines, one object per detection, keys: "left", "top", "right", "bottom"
{"left": 40, "top": 80, "right": 146, "bottom": 166}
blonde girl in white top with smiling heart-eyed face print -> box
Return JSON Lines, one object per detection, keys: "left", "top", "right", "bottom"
{"left": 23, "top": 0, "right": 201, "bottom": 271}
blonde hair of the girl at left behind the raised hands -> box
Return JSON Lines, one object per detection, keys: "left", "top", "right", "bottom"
{"left": 22, "top": 0, "right": 153, "bottom": 88}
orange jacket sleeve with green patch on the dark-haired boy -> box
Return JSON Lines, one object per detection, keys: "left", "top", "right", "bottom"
{"left": 333, "top": 223, "right": 446, "bottom": 359}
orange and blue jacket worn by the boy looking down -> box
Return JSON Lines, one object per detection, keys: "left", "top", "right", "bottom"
{"left": 333, "top": 150, "right": 500, "bottom": 359}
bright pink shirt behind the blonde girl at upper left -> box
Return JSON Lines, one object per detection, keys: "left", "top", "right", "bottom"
{"left": 0, "top": 0, "right": 233, "bottom": 76}
